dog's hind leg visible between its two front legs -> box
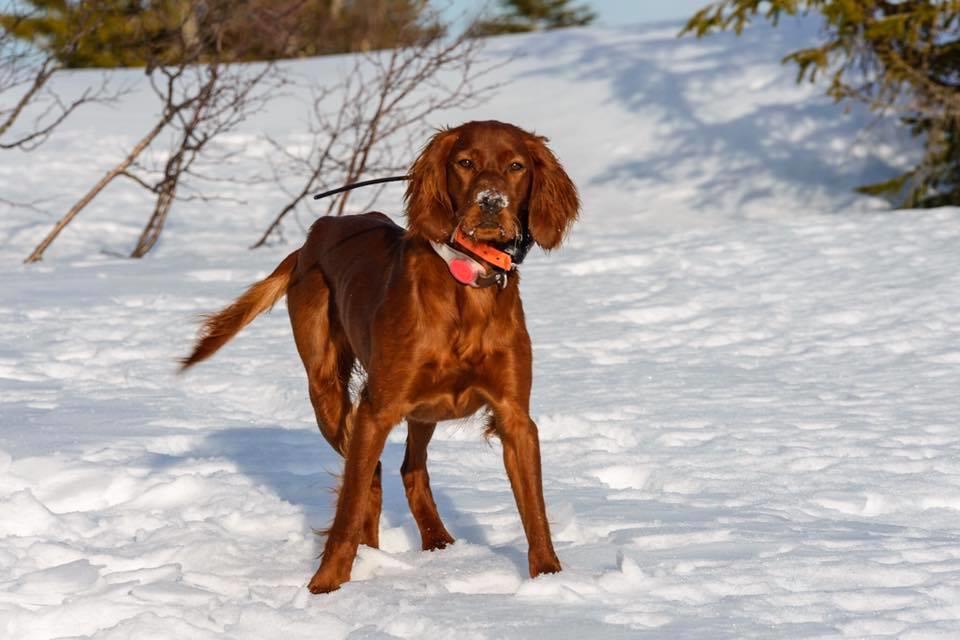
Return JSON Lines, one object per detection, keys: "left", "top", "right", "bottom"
{"left": 400, "top": 418, "right": 453, "bottom": 551}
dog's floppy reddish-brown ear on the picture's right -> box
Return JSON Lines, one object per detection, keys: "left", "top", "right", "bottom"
{"left": 527, "top": 135, "right": 580, "bottom": 251}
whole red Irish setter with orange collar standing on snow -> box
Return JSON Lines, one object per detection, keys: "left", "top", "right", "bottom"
{"left": 182, "top": 121, "right": 580, "bottom": 593}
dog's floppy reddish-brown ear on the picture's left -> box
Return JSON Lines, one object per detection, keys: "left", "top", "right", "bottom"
{"left": 404, "top": 129, "right": 458, "bottom": 242}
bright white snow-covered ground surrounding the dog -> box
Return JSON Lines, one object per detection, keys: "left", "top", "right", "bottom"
{"left": 0, "top": 17, "right": 960, "bottom": 640}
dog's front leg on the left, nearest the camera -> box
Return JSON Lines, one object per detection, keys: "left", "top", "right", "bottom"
{"left": 308, "top": 394, "right": 399, "bottom": 593}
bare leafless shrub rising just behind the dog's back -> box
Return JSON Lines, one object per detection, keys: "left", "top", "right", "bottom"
{"left": 251, "top": 21, "right": 495, "bottom": 248}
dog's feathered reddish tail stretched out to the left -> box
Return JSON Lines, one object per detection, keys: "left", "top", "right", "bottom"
{"left": 180, "top": 249, "right": 300, "bottom": 371}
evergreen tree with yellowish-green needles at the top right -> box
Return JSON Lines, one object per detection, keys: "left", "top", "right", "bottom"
{"left": 683, "top": 0, "right": 960, "bottom": 207}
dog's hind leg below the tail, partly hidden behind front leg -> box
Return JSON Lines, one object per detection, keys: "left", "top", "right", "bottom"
{"left": 287, "top": 272, "right": 383, "bottom": 547}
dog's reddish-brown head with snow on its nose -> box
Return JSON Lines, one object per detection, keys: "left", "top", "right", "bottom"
{"left": 406, "top": 121, "right": 580, "bottom": 249}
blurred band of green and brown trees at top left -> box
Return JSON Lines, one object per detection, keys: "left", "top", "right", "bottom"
{"left": 0, "top": 0, "right": 441, "bottom": 67}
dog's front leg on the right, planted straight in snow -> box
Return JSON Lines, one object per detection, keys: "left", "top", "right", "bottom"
{"left": 494, "top": 405, "right": 560, "bottom": 578}
